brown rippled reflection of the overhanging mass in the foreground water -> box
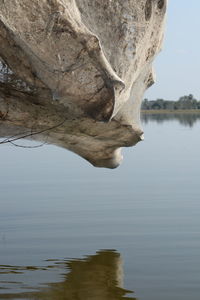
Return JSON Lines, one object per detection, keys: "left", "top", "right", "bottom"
{"left": 0, "top": 250, "right": 136, "bottom": 300}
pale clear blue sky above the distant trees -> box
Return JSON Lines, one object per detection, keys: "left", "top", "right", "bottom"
{"left": 145, "top": 0, "right": 200, "bottom": 100}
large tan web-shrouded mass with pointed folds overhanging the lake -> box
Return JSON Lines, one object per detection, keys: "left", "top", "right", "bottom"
{"left": 0, "top": 0, "right": 166, "bottom": 167}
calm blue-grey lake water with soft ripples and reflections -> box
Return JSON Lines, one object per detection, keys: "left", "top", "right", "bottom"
{"left": 0, "top": 115, "right": 200, "bottom": 300}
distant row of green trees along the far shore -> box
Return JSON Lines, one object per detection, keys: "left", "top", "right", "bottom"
{"left": 142, "top": 94, "right": 200, "bottom": 110}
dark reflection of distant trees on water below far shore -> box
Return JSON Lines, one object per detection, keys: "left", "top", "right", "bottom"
{"left": 141, "top": 113, "right": 200, "bottom": 127}
